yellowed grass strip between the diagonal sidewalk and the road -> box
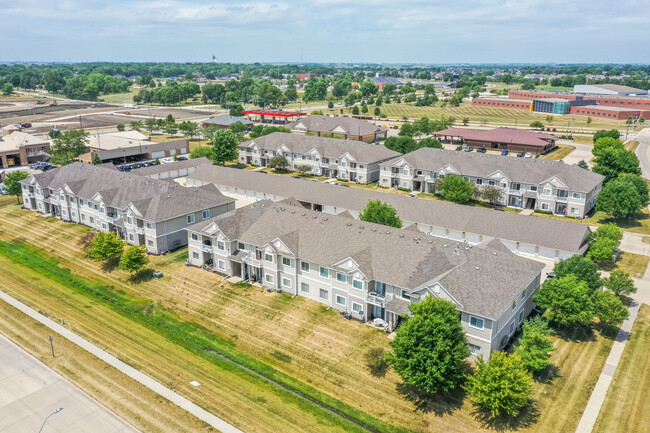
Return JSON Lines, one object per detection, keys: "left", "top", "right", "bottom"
{"left": 0, "top": 301, "right": 214, "bottom": 433}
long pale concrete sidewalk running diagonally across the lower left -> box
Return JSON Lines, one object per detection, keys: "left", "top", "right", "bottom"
{"left": 0, "top": 291, "right": 243, "bottom": 433}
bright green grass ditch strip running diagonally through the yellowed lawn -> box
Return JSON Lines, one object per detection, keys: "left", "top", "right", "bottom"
{"left": 0, "top": 241, "right": 398, "bottom": 431}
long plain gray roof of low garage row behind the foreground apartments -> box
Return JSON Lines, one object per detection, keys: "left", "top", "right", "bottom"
{"left": 188, "top": 165, "right": 590, "bottom": 254}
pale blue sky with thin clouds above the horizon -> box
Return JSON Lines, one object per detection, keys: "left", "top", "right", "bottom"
{"left": 0, "top": 0, "right": 650, "bottom": 64}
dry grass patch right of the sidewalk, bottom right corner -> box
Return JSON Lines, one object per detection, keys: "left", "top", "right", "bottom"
{"left": 593, "top": 305, "right": 650, "bottom": 433}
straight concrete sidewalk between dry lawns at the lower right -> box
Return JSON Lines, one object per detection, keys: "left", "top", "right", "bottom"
{"left": 576, "top": 301, "right": 641, "bottom": 433}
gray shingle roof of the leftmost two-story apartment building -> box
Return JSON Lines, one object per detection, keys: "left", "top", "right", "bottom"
{"left": 22, "top": 163, "right": 233, "bottom": 222}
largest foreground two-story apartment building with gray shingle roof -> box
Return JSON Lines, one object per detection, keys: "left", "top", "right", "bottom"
{"left": 187, "top": 200, "right": 544, "bottom": 356}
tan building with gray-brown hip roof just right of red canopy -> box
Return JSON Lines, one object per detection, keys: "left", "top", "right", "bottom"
{"left": 287, "top": 114, "right": 388, "bottom": 143}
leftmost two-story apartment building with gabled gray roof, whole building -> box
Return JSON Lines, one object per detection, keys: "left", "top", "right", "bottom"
{"left": 21, "top": 163, "right": 235, "bottom": 254}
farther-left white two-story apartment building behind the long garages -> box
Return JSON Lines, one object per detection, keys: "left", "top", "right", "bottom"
{"left": 239, "top": 132, "right": 400, "bottom": 183}
